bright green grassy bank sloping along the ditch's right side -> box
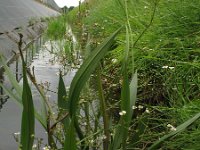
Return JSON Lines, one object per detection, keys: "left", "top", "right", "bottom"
{"left": 68, "top": 0, "right": 200, "bottom": 149}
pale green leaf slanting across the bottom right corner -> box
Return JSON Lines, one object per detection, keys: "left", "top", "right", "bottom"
{"left": 149, "top": 113, "right": 200, "bottom": 150}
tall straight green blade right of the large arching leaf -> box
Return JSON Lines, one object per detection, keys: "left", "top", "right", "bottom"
{"left": 110, "top": 27, "right": 133, "bottom": 150}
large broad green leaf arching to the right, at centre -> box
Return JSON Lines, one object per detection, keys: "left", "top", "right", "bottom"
{"left": 69, "top": 28, "right": 121, "bottom": 116}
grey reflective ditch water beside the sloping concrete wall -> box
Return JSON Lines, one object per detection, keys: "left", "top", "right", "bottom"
{"left": 0, "top": 38, "right": 76, "bottom": 150}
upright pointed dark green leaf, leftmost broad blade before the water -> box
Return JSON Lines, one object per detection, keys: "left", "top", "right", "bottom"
{"left": 20, "top": 59, "right": 35, "bottom": 150}
